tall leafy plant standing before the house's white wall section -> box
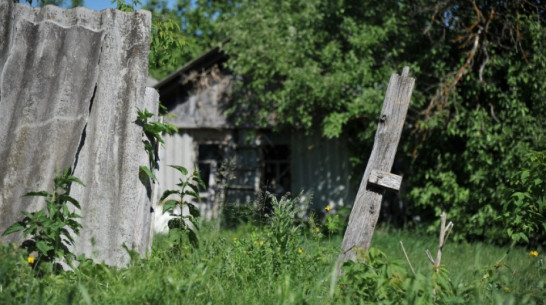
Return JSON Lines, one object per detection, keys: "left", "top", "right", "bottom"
{"left": 159, "top": 165, "right": 205, "bottom": 247}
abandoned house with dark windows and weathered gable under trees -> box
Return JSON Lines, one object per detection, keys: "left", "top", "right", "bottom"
{"left": 151, "top": 48, "right": 352, "bottom": 228}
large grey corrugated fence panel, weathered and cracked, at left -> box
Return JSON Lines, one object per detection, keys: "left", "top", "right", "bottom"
{"left": 0, "top": 0, "right": 157, "bottom": 265}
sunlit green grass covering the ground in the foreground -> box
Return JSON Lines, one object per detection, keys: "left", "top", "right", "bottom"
{"left": 0, "top": 221, "right": 546, "bottom": 304}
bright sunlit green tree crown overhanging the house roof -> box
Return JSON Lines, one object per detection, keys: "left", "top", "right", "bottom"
{"left": 223, "top": 0, "right": 399, "bottom": 132}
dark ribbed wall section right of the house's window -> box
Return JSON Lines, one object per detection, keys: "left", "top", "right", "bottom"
{"left": 290, "top": 133, "right": 350, "bottom": 208}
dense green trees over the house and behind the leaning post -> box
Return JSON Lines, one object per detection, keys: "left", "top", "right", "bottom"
{"left": 220, "top": 0, "right": 546, "bottom": 241}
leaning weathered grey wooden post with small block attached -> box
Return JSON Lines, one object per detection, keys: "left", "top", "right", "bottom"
{"left": 338, "top": 67, "right": 415, "bottom": 263}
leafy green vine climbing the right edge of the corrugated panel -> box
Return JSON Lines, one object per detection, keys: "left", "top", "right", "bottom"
{"left": 137, "top": 108, "right": 178, "bottom": 180}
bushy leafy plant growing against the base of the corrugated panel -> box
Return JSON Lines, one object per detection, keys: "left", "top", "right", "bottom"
{"left": 2, "top": 168, "right": 84, "bottom": 272}
